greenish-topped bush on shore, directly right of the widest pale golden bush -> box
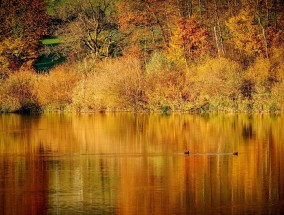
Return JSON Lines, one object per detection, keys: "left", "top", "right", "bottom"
{"left": 145, "top": 53, "right": 186, "bottom": 112}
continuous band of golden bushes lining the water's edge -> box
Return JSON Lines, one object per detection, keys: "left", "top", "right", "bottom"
{"left": 0, "top": 53, "right": 284, "bottom": 112}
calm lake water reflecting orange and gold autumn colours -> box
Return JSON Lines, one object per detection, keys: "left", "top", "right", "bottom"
{"left": 0, "top": 113, "right": 284, "bottom": 215}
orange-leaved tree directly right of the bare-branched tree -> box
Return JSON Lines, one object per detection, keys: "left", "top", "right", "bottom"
{"left": 117, "top": 0, "right": 178, "bottom": 56}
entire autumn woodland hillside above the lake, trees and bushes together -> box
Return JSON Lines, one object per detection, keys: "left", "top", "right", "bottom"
{"left": 0, "top": 0, "right": 284, "bottom": 112}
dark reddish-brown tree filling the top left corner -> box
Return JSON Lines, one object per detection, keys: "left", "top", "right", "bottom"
{"left": 0, "top": 0, "right": 49, "bottom": 71}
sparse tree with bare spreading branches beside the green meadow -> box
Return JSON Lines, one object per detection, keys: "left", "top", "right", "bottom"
{"left": 50, "top": 0, "right": 121, "bottom": 59}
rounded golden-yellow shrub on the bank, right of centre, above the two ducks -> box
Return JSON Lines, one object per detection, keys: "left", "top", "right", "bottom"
{"left": 190, "top": 58, "right": 242, "bottom": 111}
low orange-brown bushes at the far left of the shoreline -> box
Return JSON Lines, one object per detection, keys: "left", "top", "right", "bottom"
{"left": 0, "top": 67, "right": 79, "bottom": 111}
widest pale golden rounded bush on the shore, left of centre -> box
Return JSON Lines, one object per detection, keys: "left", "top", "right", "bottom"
{"left": 73, "top": 57, "right": 144, "bottom": 111}
